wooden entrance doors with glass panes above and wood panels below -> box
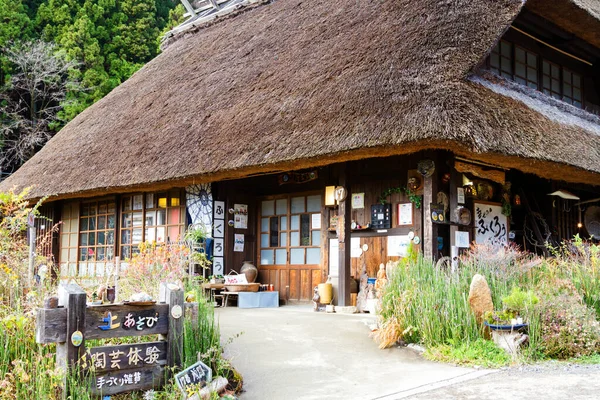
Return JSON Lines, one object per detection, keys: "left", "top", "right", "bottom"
{"left": 258, "top": 193, "right": 324, "bottom": 301}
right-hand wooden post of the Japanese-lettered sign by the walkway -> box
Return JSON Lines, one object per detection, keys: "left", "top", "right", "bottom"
{"left": 166, "top": 284, "right": 184, "bottom": 368}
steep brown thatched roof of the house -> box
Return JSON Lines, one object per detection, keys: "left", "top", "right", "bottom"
{"left": 0, "top": 0, "right": 600, "bottom": 198}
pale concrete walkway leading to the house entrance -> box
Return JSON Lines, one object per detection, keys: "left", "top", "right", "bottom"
{"left": 216, "top": 306, "right": 494, "bottom": 400}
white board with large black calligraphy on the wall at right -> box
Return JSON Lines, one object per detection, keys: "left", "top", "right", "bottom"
{"left": 474, "top": 202, "right": 508, "bottom": 246}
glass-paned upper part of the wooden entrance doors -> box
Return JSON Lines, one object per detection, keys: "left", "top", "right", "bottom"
{"left": 260, "top": 195, "right": 321, "bottom": 265}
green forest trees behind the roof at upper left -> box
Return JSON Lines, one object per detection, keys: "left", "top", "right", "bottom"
{"left": 0, "top": 0, "right": 183, "bottom": 170}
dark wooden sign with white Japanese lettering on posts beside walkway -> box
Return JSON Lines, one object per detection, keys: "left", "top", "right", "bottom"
{"left": 36, "top": 284, "right": 184, "bottom": 395}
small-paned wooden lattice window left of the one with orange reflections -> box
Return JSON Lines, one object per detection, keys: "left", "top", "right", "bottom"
{"left": 78, "top": 200, "right": 116, "bottom": 262}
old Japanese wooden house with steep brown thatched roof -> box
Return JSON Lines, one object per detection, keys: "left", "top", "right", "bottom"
{"left": 0, "top": 0, "right": 600, "bottom": 302}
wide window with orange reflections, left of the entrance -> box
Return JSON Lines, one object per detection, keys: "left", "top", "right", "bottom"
{"left": 120, "top": 190, "right": 185, "bottom": 260}
